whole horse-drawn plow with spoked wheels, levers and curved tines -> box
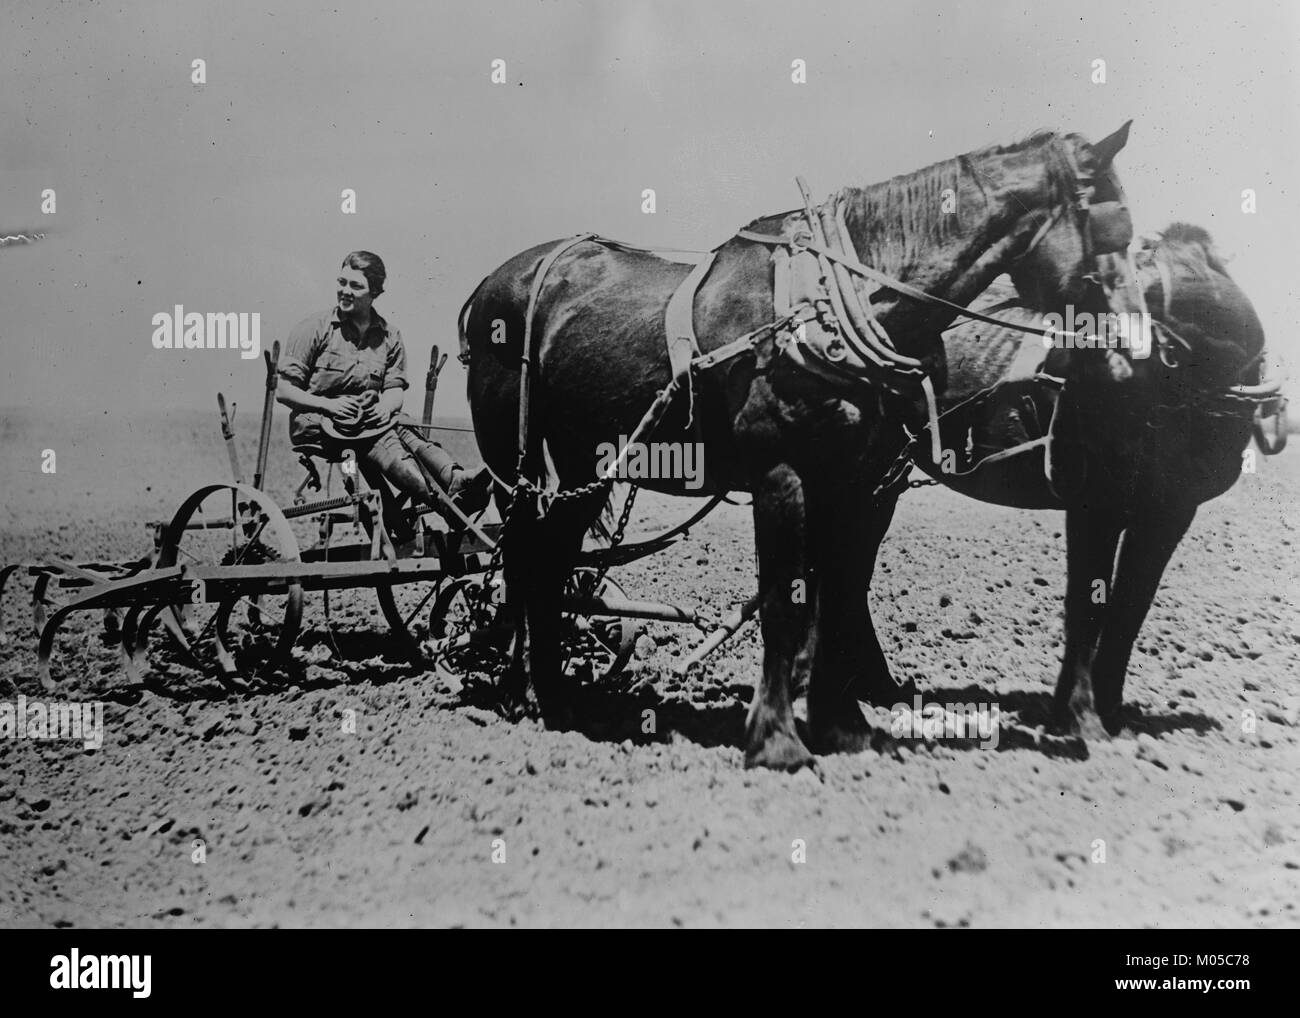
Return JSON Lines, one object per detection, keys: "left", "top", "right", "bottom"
{"left": 0, "top": 342, "right": 758, "bottom": 692}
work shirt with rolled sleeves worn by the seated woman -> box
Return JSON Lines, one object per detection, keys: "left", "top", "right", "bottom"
{"left": 278, "top": 307, "right": 408, "bottom": 447}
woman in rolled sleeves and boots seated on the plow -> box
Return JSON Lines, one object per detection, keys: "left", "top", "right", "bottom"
{"left": 276, "top": 251, "right": 491, "bottom": 543}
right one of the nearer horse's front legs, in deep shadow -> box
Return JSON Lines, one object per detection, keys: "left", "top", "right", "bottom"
{"left": 809, "top": 482, "right": 901, "bottom": 753}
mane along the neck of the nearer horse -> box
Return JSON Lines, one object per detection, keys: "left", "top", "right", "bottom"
{"left": 841, "top": 130, "right": 1075, "bottom": 282}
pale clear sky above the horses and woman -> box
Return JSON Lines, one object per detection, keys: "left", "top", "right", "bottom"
{"left": 0, "top": 0, "right": 1300, "bottom": 413}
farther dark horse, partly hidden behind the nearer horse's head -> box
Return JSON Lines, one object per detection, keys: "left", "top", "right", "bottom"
{"left": 899, "top": 224, "right": 1264, "bottom": 736}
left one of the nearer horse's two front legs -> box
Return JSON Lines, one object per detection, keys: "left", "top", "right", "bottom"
{"left": 745, "top": 464, "right": 816, "bottom": 771}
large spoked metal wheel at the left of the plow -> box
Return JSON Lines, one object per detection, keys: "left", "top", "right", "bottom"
{"left": 150, "top": 484, "right": 303, "bottom": 679}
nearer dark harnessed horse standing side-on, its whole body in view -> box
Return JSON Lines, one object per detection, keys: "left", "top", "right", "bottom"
{"left": 462, "top": 125, "right": 1131, "bottom": 770}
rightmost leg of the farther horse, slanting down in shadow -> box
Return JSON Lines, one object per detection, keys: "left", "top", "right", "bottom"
{"left": 1092, "top": 504, "right": 1196, "bottom": 735}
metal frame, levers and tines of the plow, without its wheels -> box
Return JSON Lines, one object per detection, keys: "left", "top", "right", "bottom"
{"left": 10, "top": 342, "right": 758, "bottom": 690}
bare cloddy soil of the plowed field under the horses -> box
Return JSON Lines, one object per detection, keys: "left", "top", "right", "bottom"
{"left": 0, "top": 405, "right": 1300, "bottom": 927}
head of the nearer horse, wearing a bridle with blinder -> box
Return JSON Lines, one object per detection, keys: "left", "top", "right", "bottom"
{"left": 1010, "top": 121, "right": 1136, "bottom": 311}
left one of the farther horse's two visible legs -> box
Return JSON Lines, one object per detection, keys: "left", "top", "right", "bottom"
{"left": 1052, "top": 508, "right": 1123, "bottom": 736}
